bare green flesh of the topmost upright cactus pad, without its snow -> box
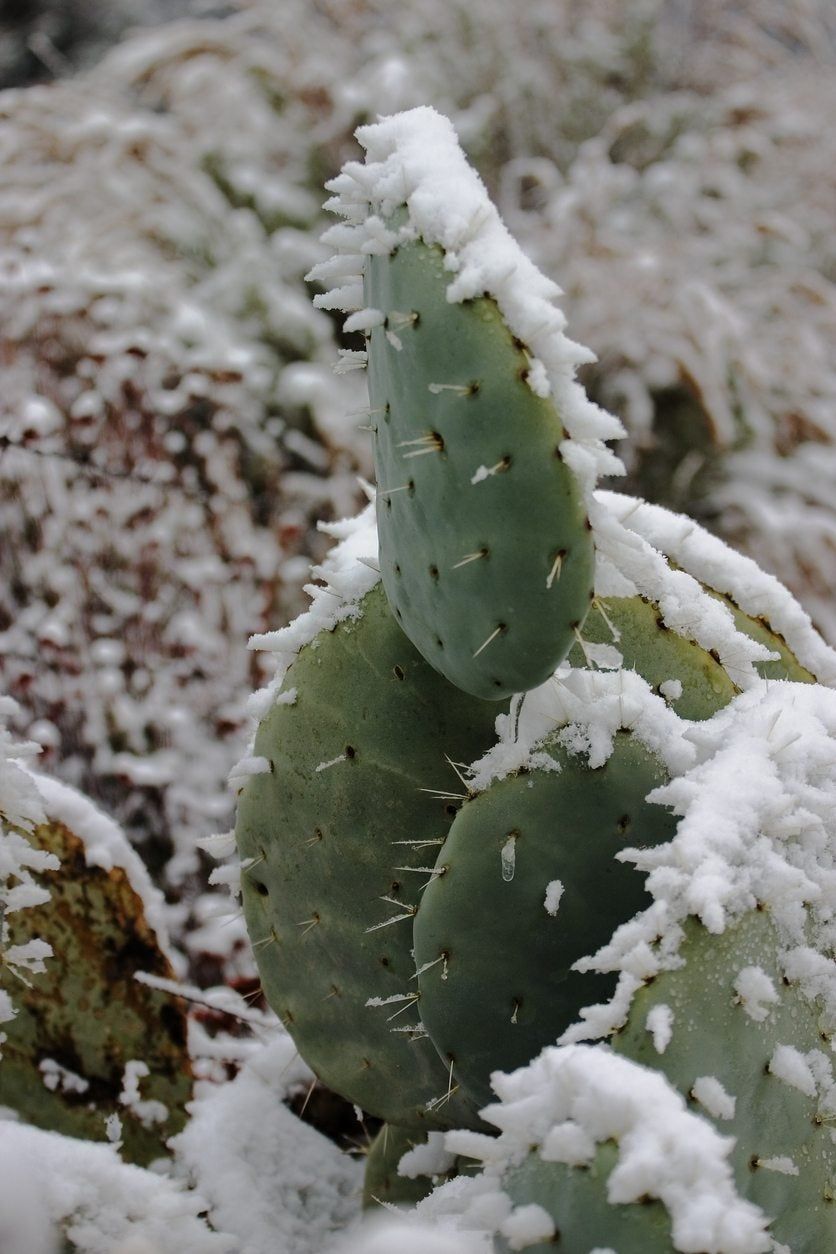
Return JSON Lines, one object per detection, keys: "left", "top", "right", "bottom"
{"left": 366, "top": 241, "right": 593, "bottom": 700}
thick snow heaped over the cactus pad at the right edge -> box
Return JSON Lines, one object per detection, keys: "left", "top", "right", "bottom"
{"left": 562, "top": 681, "right": 836, "bottom": 1043}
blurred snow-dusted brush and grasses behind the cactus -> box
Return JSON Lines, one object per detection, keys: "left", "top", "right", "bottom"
{"left": 0, "top": 0, "right": 836, "bottom": 986}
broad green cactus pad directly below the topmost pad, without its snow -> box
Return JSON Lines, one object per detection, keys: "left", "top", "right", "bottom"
{"left": 231, "top": 586, "right": 496, "bottom": 1127}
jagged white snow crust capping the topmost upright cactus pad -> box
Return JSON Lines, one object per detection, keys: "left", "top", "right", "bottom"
{"left": 308, "top": 107, "right": 624, "bottom": 493}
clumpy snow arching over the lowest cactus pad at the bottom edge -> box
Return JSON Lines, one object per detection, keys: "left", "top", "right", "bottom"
{"left": 441, "top": 1045, "right": 772, "bottom": 1254}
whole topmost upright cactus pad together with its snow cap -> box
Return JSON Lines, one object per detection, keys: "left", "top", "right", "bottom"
{"left": 311, "top": 109, "right": 620, "bottom": 700}
